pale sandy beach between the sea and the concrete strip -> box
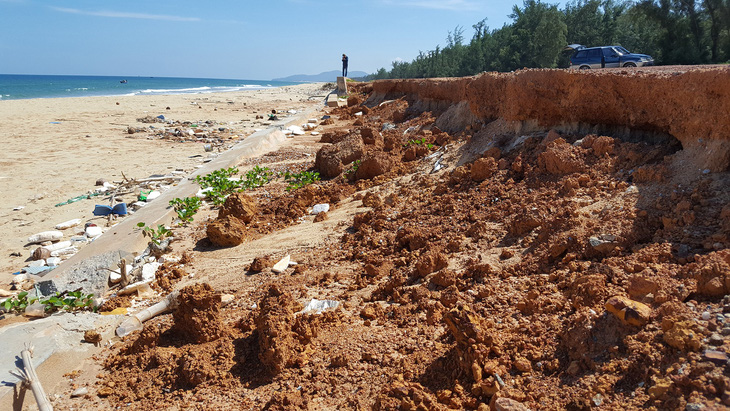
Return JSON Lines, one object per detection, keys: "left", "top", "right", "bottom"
{"left": 0, "top": 83, "right": 329, "bottom": 289}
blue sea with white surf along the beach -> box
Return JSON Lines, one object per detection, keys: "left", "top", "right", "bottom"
{"left": 0, "top": 74, "right": 300, "bottom": 100}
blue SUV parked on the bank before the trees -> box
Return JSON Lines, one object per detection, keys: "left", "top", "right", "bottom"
{"left": 569, "top": 44, "right": 654, "bottom": 70}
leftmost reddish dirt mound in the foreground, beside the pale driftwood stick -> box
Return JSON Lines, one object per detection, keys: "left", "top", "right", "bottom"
{"left": 97, "top": 284, "right": 236, "bottom": 408}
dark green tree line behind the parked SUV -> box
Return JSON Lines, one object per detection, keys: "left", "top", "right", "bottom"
{"left": 369, "top": 0, "right": 730, "bottom": 79}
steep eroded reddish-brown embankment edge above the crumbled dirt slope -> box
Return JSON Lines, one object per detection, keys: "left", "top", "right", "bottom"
{"left": 368, "top": 67, "right": 730, "bottom": 171}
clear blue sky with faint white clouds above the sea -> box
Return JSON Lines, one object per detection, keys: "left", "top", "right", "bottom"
{"left": 0, "top": 0, "right": 562, "bottom": 80}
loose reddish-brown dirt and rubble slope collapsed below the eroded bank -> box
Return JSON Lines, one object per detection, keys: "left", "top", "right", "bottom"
{"left": 99, "top": 68, "right": 730, "bottom": 410}
